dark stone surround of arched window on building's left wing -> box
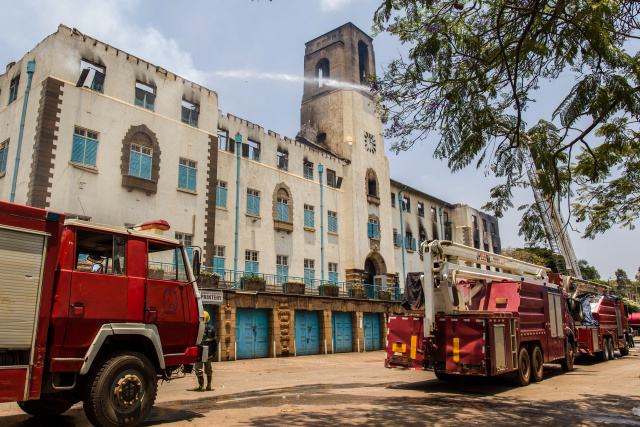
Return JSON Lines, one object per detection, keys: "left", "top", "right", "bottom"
{"left": 120, "top": 125, "right": 160, "bottom": 196}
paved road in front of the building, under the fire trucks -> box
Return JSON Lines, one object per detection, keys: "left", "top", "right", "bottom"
{"left": 0, "top": 341, "right": 640, "bottom": 427}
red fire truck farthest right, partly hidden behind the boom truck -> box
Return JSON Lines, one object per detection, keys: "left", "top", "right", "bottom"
{"left": 564, "top": 277, "right": 632, "bottom": 362}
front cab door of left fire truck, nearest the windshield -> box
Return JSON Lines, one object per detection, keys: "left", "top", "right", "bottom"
{"left": 144, "top": 242, "right": 189, "bottom": 353}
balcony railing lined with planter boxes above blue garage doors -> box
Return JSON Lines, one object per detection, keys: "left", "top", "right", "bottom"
{"left": 198, "top": 267, "right": 401, "bottom": 301}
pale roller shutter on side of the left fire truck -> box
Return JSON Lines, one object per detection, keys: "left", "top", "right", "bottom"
{"left": 0, "top": 228, "right": 47, "bottom": 350}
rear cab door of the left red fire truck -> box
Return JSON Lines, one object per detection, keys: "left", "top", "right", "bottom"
{"left": 64, "top": 229, "right": 128, "bottom": 351}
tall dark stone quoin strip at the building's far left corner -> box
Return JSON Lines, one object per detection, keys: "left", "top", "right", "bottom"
{"left": 27, "top": 77, "right": 63, "bottom": 209}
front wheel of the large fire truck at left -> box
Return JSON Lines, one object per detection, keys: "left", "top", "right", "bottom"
{"left": 84, "top": 351, "right": 158, "bottom": 427}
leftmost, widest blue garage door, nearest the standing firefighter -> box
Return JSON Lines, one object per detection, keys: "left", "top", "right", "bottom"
{"left": 236, "top": 308, "right": 269, "bottom": 359}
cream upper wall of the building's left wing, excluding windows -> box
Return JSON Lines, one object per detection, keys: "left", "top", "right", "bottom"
{"left": 0, "top": 25, "right": 218, "bottom": 258}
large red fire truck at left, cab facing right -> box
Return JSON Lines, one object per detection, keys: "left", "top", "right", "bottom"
{"left": 0, "top": 202, "right": 207, "bottom": 426}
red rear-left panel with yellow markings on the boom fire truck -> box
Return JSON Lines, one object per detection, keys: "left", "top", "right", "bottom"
{"left": 384, "top": 316, "right": 424, "bottom": 370}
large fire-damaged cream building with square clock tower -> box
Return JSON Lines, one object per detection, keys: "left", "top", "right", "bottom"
{"left": 0, "top": 23, "right": 500, "bottom": 359}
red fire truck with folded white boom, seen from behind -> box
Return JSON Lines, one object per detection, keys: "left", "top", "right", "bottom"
{"left": 385, "top": 240, "right": 575, "bottom": 386}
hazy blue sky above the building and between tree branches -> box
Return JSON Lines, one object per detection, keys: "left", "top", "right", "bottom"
{"left": 0, "top": 0, "right": 640, "bottom": 280}
